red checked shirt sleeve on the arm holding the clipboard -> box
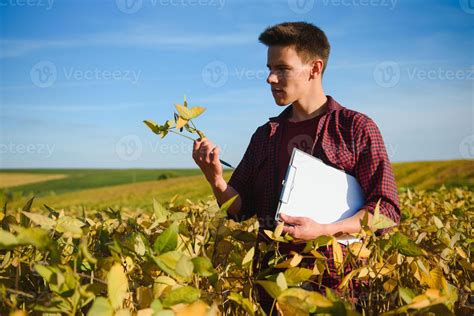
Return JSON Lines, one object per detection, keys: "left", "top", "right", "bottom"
{"left": 355, "top": 118, "right": 400, "bottom": 233}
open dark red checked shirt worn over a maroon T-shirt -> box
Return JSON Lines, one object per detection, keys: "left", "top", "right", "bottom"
{"left": 229, "top": 96, "right": 400, "bottom": 294}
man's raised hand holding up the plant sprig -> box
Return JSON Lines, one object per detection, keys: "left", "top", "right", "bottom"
{"left": 193, "top": 138, "right": 223, "bottom": 185}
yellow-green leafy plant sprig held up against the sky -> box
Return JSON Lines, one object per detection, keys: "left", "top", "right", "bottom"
{"left": 143, "top": 96, "right": 234, "bottom": 169}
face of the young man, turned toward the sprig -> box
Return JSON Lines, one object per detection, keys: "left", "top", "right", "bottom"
{"left": 267, "top": 46, "right": 312, "bottom": 105}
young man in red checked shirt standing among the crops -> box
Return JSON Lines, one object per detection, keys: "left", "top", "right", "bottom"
{"left": 193, "top": 22, "right": 400, "bottom": 312}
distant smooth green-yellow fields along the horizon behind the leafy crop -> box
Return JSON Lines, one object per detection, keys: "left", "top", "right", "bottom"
{"left": 0, "top": 160, "right": 474, "bottom": 209}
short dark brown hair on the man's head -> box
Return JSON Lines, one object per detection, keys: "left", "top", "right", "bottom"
{"left": 258, "top": 22, "right": 331, "bottom": 74}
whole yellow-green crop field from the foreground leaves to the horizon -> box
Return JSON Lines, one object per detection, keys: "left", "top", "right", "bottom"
{"left": 0, "top": 160, "right": 474, "bottom": 316}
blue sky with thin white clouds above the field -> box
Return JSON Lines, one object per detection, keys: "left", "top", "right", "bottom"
{"left": 0, "top": 0, "right": 474, "bottom": 168}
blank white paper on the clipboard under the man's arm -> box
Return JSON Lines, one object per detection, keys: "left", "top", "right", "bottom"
{"left": 275, "top": 148, "right": 364, "bottom": 244}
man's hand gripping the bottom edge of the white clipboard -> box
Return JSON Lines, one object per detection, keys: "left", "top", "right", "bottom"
{"left": 280, "top": 214, "right": 328, "bottom": 240}
